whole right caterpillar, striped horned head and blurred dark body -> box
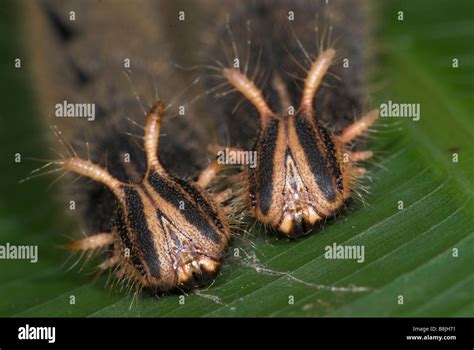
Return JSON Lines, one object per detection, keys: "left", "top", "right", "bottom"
{"left": 199, "top": 1, "right": 378, "bottom": 237}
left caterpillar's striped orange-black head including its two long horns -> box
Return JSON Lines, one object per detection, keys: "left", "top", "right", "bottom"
{"left": 64, "top": 102, "right": 230, "bottom": 291}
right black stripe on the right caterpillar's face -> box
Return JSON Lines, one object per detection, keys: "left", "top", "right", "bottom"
{"left": 294, "top": 115, "right": 336, "bottom": 202}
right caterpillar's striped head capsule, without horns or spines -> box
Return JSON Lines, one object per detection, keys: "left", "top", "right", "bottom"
{"left": 248, "top": 112, "right": 349, "bottom": 237}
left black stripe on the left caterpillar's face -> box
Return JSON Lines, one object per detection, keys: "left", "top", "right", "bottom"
{"left": 124, "top": 186, "right": 160, "bottom": 278}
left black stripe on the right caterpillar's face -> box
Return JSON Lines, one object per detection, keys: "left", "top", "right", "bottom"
{"left": 257, "top": 119, "right": 279, "bottom": 215}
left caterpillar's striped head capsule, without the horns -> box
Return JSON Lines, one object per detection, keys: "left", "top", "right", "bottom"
{"left": 116, "top": 170, "right": 229, "bottom": 290}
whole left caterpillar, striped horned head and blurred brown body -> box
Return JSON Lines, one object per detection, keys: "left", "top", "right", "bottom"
{"left": 28, "top": 1, "right": 230, "bottom": 291}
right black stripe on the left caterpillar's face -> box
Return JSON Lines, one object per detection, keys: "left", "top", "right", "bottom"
{"left": 148, "top": 172, "right": 220, "bottom": 243}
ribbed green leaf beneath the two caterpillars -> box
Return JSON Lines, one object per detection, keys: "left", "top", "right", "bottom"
{"left": 0, "top": 0, "right": 474, "bottom": 316}
